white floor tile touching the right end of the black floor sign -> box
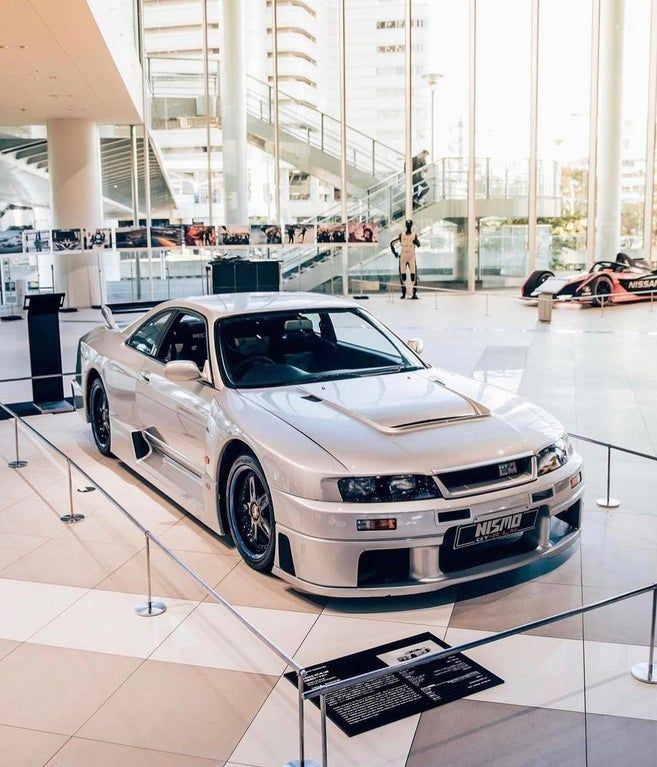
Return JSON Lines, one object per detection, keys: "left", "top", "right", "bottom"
{"left": 445, "top": 629, "right": 588, "bottom": 711}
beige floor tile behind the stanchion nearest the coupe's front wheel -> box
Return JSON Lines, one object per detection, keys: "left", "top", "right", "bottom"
{"left": 99, "top": 544, "right": 236, "bottom": 600}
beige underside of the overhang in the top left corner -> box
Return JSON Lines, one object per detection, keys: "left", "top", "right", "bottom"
{"left": 0, "top": 0, "right": 141, "bottom": 125}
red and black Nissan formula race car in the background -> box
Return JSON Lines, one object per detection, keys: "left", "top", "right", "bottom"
{"left": 522, "top": 253, "right": 657, "bottom": 306}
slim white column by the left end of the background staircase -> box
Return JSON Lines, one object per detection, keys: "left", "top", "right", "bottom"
{"left": 220, "top": 0, "right": 249, "bottom": 224}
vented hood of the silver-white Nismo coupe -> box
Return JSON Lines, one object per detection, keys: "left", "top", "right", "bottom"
{"left": 241, "top": 368, "right": 563, "bottom": 474}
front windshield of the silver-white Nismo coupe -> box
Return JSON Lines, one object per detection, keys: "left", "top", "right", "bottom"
{"left": 216, "top": 309, "right": 422, "bottom": 389}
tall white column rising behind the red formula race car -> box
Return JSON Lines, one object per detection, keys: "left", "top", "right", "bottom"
{"left": 595, "top": 0, "right": 625, "bottom": 261}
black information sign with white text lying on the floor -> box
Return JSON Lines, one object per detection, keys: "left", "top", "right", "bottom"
{"left": 285, "top": 632, "right": 504, "bottom": 738}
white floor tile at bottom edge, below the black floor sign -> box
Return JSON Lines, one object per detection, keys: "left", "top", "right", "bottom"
{"left": 231, "top": 679, "right": 419, "bottom": 767}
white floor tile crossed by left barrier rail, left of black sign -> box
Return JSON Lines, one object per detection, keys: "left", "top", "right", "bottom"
{"left": 152, "top": 602, "right": 317, "bottom": 675}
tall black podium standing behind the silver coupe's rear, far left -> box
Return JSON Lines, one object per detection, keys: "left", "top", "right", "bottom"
{"left": 23, "top": 293, "right": 71, "bottom": 413}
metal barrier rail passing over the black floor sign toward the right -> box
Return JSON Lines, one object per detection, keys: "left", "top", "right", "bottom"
{"left": 303, "top": 582, "right": 657, "bottom": 700}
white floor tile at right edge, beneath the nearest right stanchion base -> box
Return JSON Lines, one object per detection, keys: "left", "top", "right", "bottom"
{"left": 585, "top": 642, "right": 657, "bottom": 721}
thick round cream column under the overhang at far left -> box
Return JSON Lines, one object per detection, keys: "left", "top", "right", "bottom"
{"left": 47, "top": 119, "right": 103, "bottom": 308}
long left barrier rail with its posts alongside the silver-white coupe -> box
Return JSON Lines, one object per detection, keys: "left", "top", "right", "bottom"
{"left": 0, "top": 402, "right": 304, "bottom": 678}
